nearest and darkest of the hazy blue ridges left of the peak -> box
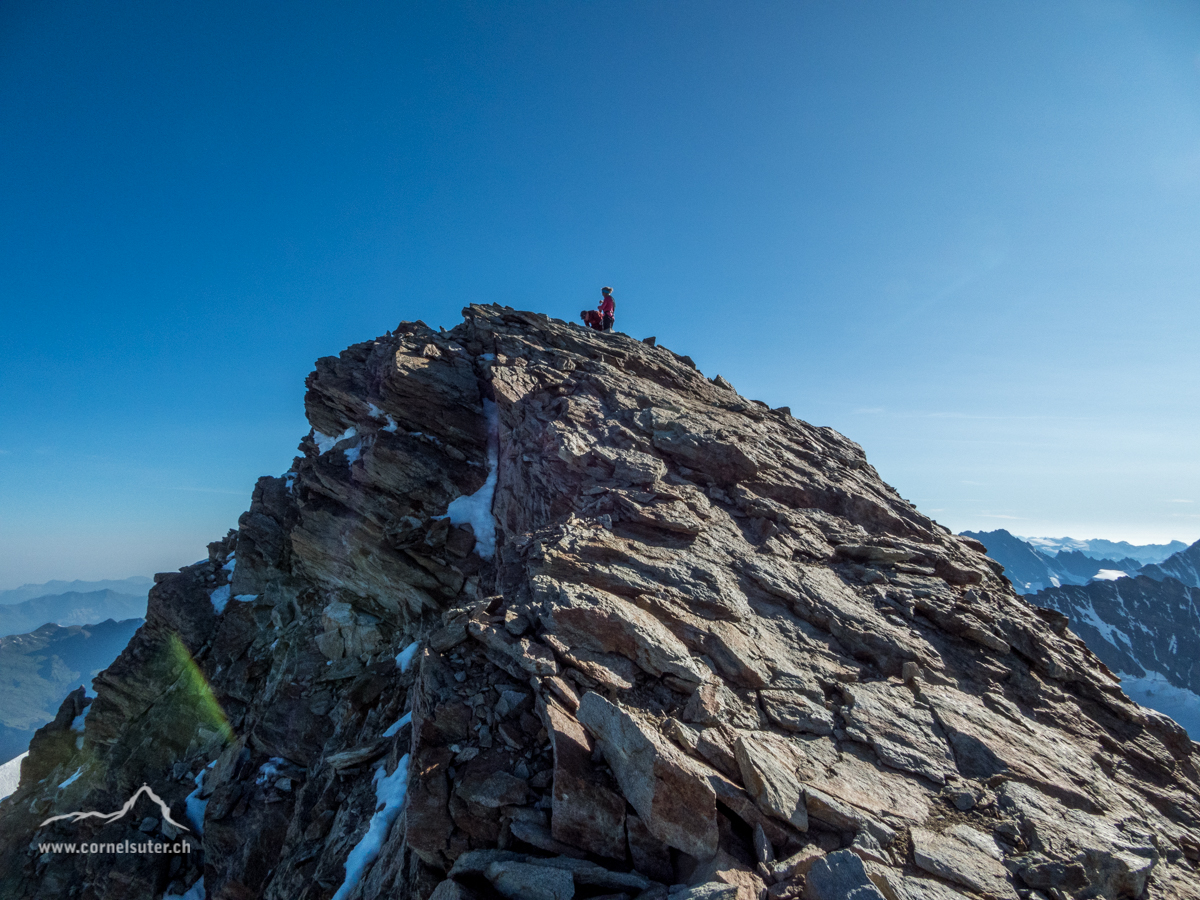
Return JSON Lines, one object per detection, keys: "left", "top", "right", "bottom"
{"left": 0, "top": 624, "right": 142, "bottom": 761}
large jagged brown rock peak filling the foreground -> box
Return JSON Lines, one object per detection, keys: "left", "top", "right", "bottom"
{"left": 0, "top": 306, "right": 1200, "bottom": 900}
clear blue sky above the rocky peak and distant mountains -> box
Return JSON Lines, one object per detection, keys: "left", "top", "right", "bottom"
{"left": 0, "top": 0, "right": 1200, "bottom": 588}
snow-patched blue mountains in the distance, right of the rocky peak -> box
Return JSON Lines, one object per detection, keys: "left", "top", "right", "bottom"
{"left": 965, "top": 530, "right": 1200, "bottom": 739}
